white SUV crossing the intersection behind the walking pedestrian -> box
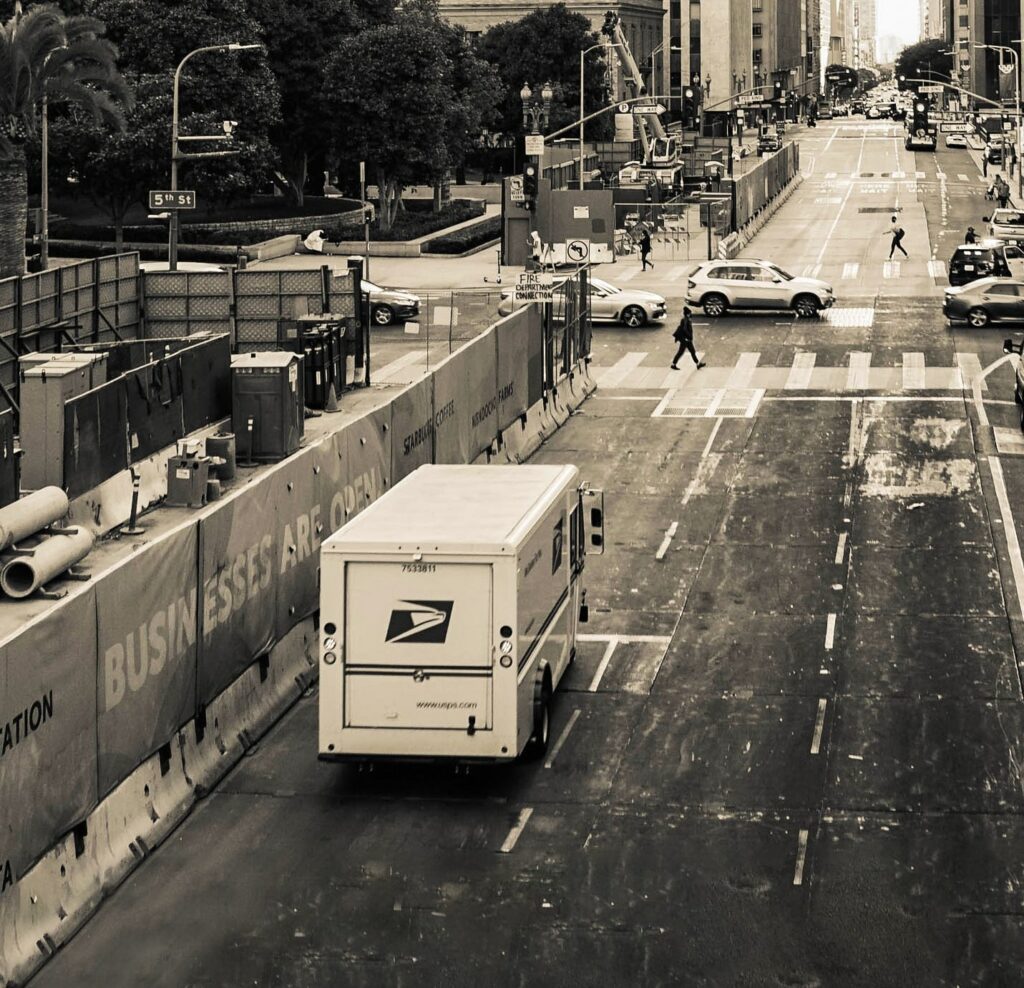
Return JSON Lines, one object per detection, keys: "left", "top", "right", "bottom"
{"left": 686, "top": 257, "right": 836, "bottom": 318}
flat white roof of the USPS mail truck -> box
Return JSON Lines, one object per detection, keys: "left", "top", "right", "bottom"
{"left": 324, "top": 465, "right": 579, "bottom": 553}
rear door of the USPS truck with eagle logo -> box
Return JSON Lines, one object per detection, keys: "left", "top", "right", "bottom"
{"left": 343, "top": 561, "right": 494, "bottom": 731}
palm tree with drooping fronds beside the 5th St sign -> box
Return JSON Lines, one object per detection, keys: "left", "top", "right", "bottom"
{"left": 0, "top": 2, "right": 130, "bottom": 277}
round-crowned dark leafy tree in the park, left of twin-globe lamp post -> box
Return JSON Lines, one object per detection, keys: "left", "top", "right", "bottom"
{"left": 323, "top": 0, "right": 499, "bottom": 229}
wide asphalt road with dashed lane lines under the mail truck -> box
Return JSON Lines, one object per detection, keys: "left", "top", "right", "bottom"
{"left": 34, "top": 119, "right": 1024, "bottom": 988}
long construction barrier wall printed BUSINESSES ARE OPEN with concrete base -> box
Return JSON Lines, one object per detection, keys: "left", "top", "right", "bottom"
{"left": 0, "top": 276, "right": 589, "bottom": 983}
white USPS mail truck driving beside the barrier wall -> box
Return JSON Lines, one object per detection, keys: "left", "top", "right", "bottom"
{"left": 319, "top": 466, "right": 604, "bottom": 762}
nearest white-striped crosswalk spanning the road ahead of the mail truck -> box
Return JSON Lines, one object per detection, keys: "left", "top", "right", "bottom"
{"left": 591, "top": 350, "right": 988, "bottom": 393}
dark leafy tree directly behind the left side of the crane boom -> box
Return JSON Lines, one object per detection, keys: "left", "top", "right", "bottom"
{"left": 477, "top": 3, "right": 610, "bottom": 140}
